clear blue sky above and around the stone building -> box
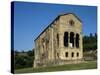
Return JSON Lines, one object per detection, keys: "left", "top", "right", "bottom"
{"left": 14, "top": 2, "right": 97, "bottom": 51}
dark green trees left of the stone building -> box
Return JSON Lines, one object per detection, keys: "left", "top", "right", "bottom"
{"left": 14, "top": 49, "right": 34, "bottom": 69}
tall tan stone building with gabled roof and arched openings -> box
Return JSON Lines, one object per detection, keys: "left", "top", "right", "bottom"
{"left": 33, "top": 13, "right": 83, "bottom": 68}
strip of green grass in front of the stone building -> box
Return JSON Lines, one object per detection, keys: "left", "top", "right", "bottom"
{"left": 15, "top": 61, "right": 97, "bottom": 73}
